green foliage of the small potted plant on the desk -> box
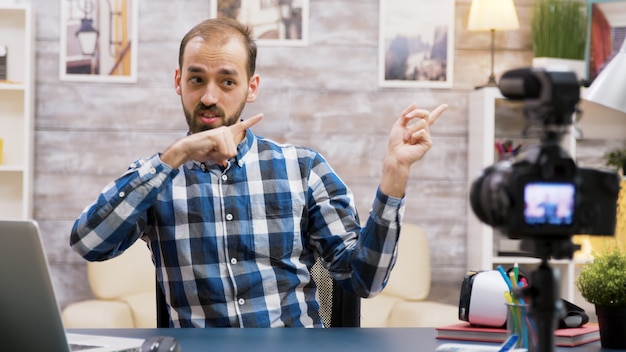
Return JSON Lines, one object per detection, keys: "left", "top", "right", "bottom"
{"left": 576, "top": 245, "right": 626, "bottom": 307}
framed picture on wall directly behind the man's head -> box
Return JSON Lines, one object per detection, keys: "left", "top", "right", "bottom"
{"left": 211, "top": 0, "right": 309, "bottom": 46}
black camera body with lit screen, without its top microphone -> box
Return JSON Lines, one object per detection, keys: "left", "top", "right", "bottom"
{"left": 470, "top": 145, "right": 619, "bottom": 238}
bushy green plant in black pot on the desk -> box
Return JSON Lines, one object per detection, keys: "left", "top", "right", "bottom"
{"left": 576, "top": 245, "right": 626, "bottom": 349}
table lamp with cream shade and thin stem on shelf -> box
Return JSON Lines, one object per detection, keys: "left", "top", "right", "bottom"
{"left": 467, "top": 0, "right": 519, "bottom": 88}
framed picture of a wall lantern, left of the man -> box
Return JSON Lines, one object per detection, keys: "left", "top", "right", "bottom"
{"left": 59, "top": 0, "right": 139, "bottom": 83}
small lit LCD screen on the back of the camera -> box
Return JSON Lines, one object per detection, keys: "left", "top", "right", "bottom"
{"left": 524, "top": 182, "right": 576, "bottom": 226}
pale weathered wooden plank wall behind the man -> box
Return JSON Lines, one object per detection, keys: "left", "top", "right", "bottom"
{"left": 21, "top": 0, "right": 532, "bottom": 306}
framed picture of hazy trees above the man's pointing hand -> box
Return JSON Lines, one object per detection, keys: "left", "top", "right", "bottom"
{"left": 378, "top": 0, "right": 454, "bottom": 88}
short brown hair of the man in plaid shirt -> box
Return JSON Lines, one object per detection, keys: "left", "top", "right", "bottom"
{"left": 178, "top": 17, "right": 257, "bottom": 78}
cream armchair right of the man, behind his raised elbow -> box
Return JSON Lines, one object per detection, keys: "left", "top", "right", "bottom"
{"left": 361, "top": 223, "right": 460, "bottom": 327}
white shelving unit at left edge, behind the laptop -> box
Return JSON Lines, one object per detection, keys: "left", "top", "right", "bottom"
{"left": 0, "top": 4, "right": 35, "bottom": 220}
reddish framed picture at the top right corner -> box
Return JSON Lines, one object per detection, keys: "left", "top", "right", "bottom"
{"left": 585, "top": 0, "right": 626, "bottom": 82}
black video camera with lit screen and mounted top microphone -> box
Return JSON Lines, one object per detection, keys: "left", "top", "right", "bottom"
{"left": 470, "top": 68, "right": 619, "bottom": 239}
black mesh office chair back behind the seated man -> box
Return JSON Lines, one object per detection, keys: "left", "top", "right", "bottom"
{"left": 156, "top": 260, "right": 361, "bottom": 328}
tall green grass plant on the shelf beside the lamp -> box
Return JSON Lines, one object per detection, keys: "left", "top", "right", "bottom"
{"left": 531, "top": 0, "right": 587, "bottom": 60}
